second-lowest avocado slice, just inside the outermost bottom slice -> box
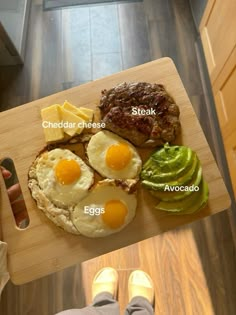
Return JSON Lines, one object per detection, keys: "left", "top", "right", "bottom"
{"left": 150, "top": 164, "right": 202, "bottom": 201}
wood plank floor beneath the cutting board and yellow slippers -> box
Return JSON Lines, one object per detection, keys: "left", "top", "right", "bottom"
{"left": 0, "top": 0, "right": 236, "bottom": 315}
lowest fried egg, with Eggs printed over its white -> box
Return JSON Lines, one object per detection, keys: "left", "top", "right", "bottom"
{"left": 71, "top": 181, "right": 137, "bottom": 237}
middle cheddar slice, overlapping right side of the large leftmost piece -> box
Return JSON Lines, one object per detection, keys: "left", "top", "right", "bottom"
{"left": 60, "top": 107, "right": 84, "bottom": 137}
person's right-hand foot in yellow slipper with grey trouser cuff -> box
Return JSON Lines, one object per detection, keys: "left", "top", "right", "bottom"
{"left": 125, "top": 270, "right": 154, "bottom": 315}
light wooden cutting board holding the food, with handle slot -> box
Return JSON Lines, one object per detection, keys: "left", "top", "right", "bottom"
{"left": 0, "top": 58, "right": 230, "bottom": 284}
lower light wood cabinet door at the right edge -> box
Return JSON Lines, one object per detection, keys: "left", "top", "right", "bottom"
{"left": 213, "top": 48, "right": 236, "bottom": 196}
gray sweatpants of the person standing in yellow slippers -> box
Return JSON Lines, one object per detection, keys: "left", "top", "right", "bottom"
{"left": 56, "top": 292, "right": 154, "bottom": 315}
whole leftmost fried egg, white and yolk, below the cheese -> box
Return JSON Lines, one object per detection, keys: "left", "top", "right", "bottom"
{"left": 36, "top": 149, "right": 94, "bottom": 207}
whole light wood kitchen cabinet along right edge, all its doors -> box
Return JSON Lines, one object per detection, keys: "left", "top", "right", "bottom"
{"left": 199, "top": 0, "right": 236, "bottom": 197}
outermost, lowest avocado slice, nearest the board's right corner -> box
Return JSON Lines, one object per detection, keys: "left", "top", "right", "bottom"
{"left": 155, "top": 179, "right": 209, "bottom": 214}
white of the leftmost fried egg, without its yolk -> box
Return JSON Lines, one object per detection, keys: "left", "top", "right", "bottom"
{"left": 36, "top": 149, "right": 94, "bottom": 207}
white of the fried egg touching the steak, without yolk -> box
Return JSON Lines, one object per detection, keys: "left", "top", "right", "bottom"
{"left": 87, "top": 131, "right": 142, "bottom": 179}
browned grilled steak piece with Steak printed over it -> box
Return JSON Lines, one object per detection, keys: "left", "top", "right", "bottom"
{"left": 99, "top": 82, "right": 180, "bottom": 146}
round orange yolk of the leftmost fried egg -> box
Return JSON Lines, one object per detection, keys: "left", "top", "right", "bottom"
{"left": 55, "top": 160, "right": 81, "bottom": 185}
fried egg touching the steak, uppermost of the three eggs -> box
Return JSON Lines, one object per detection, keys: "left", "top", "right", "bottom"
{"left": 87, "top": 131, "right": 142, "bottom": 179}
